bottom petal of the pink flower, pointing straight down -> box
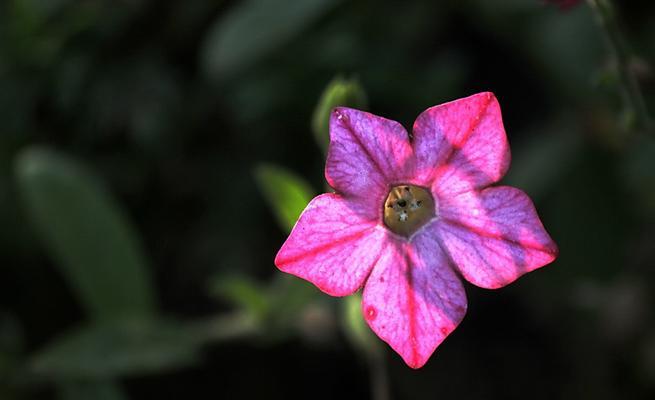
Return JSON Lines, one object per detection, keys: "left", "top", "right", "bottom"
{"left": 362, "top": 231, "right": 466, "bottom": 368}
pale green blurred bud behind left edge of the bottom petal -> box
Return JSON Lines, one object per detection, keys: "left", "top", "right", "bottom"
{"left": 341, "top": 293, "right": 380, "bottom": 353}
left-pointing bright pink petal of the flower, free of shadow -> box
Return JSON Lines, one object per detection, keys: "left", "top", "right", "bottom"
{"left": 275, "top": 193, "right": 387, "bottom": 296}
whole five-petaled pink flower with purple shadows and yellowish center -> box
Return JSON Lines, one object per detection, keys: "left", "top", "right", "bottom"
{"left": 275, "top": 93, "right": 557, "bottom": 368}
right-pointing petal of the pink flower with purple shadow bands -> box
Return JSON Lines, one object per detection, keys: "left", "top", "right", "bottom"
{"left": 434, "top": 186, "right": 557, "bottom": 289}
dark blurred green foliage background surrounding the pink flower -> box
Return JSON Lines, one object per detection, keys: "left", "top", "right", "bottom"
{"left": 0, "top": 0, "right": 655, "bottom": 400}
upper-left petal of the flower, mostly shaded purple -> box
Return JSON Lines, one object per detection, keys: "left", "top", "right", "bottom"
{"left": 325, "top": 107, "right": 414, "bottom": 207}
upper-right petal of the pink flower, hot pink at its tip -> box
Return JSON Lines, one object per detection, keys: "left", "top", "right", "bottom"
{"left": 413, "top": 92, "right": 510, "bottom": 195}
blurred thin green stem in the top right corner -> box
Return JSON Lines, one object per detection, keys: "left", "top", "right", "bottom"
{"left": 587, "top": 0, "right": 653, "bottom": 132}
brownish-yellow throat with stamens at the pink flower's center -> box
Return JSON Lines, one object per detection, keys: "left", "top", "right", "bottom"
{"left": 384, "top": 185, "right": 435, "bottom": 237}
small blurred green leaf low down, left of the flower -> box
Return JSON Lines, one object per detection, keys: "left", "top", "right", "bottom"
{"left": 209, "top": 276, "right": 270, "bottom": 320}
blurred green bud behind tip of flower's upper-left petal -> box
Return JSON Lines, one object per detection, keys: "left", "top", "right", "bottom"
{"left": 312, "top": 76, "right": 368, "bottom": 152}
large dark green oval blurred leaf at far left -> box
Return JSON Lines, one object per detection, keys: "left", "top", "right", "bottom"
{"left": 15, "top": 148, "right": 155, "bottom": 319}
